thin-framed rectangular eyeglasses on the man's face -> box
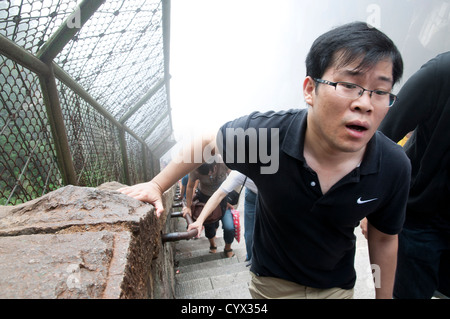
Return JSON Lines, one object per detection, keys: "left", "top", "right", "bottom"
{"left": 314, "top": 79, "right": 398, "bottom": 107}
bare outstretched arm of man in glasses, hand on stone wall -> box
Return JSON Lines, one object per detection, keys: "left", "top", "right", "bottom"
{"left": 118, "top": 132, "right": 217, "bottom": 217}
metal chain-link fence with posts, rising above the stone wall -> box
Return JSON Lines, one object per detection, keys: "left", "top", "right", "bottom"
{"left": 0, "top": 0, "right": 174, "bottom": 205}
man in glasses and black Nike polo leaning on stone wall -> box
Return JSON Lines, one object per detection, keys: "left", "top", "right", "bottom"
{"left": 118, "top": 23, "right": 410, "bottom": 298}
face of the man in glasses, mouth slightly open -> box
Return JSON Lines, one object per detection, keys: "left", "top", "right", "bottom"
{"left": 304, "top": 59, "right": 393, "bottom": 156}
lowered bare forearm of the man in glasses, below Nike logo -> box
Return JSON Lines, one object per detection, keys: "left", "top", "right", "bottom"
{"left": 367, "top": 222, "right": 398, "bottom": 299}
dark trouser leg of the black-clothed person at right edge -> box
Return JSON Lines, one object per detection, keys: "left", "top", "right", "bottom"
{"left": 394, "top": 226, "right": 442, "bottom": 299}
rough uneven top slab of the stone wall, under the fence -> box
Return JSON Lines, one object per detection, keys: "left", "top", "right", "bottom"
{"left": 0, "top": 182, "right": 153, "bottom": 236}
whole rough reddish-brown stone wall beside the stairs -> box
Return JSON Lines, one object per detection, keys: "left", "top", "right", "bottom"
{"left": 0, "top": 183, "right": 174, "bottom": 298}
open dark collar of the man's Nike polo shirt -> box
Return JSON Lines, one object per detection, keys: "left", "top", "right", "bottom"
{"left": 281, "top": 109, "right": 381, "bottom": 175}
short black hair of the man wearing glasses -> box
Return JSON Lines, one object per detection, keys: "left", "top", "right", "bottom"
{"left": 306, "top": 22, "right": 403, "bottom": 84}
